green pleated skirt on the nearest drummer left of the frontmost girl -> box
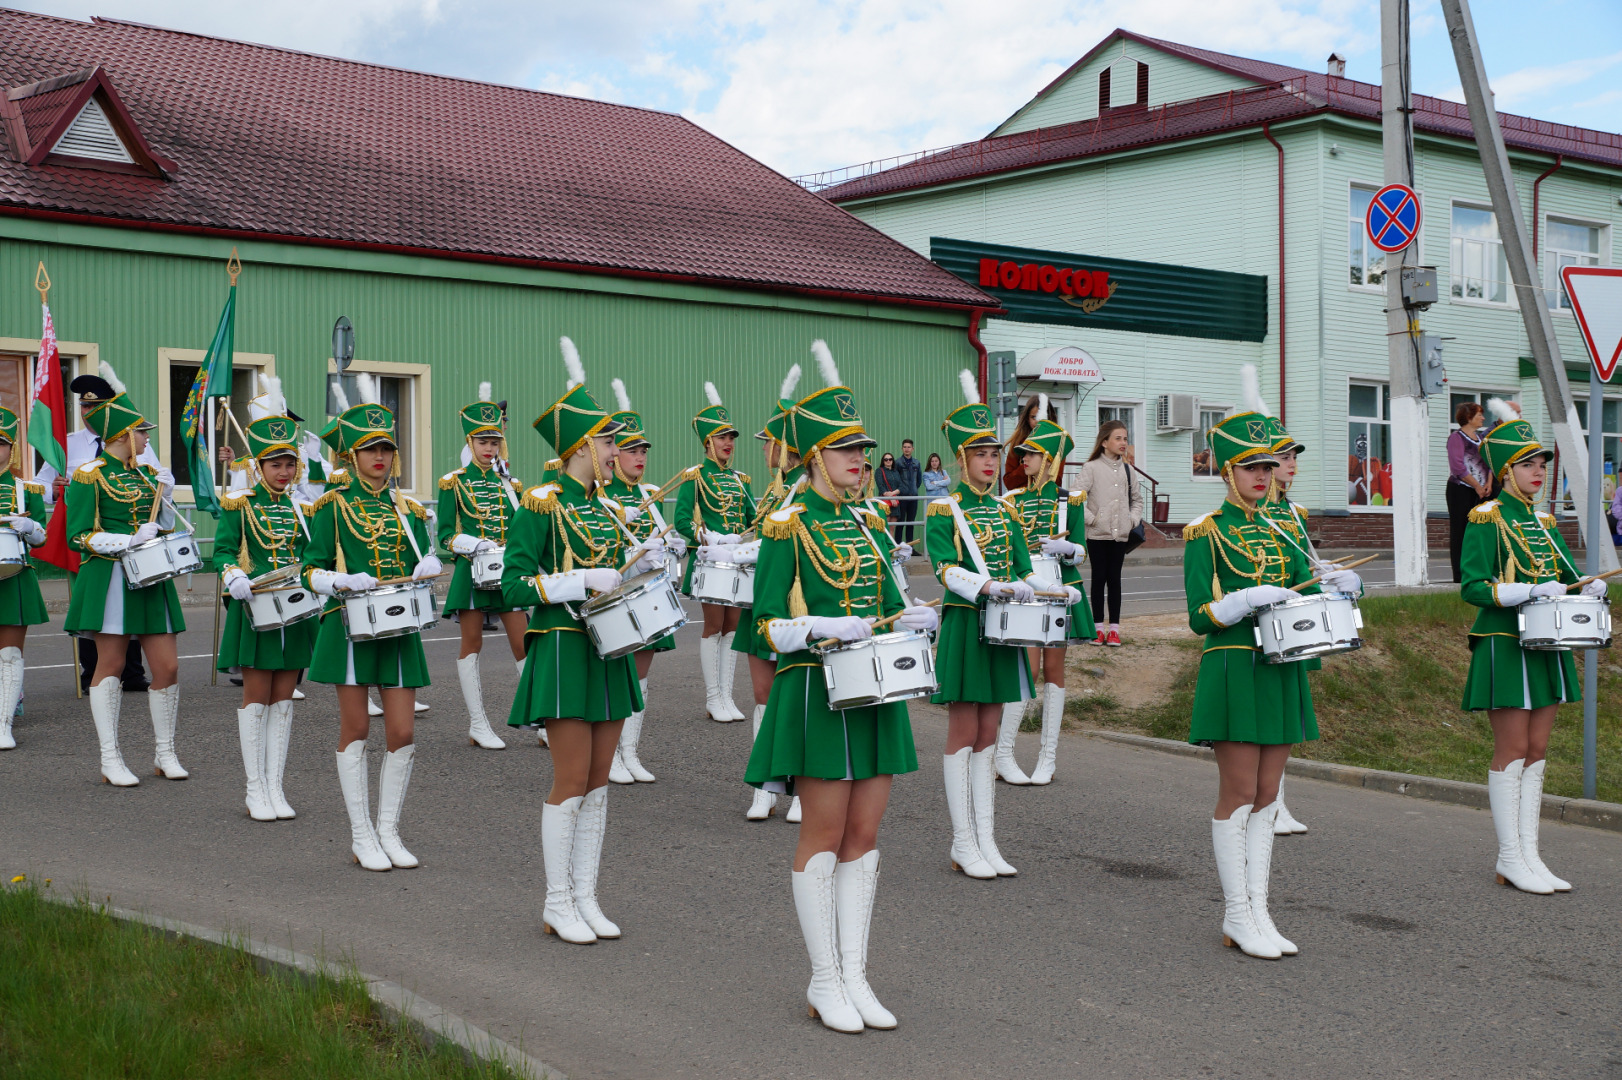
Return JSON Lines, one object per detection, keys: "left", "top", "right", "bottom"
{"left": 508, "top": 629, "right": 642, "bottom": 728}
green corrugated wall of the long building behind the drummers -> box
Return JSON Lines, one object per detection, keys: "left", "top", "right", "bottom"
{"left": 0, "top": 219, "right": 976, "bottom": 505}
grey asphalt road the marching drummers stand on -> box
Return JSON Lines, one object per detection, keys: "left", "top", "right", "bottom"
{"left": 0, "top": 580, "right": 1622, "bottom": 1080}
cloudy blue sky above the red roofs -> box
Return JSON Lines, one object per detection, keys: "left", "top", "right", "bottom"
{"left": 10, "top": 0, "right": 1622, "bottom": 175}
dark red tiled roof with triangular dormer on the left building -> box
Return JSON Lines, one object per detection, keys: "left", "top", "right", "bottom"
{"left": 0, "top": 10, "right": 996, "bottom": 306}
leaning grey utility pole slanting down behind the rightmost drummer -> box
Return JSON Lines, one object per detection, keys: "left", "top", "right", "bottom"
{"left": 1442, "top": 0, "right": 1617, "bottom": 569}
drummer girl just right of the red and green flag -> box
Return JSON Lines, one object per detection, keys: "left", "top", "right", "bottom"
{"left": 63, "top": 362, "right": 190, "bottom": 788}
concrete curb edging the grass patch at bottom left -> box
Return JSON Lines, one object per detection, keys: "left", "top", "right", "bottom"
{"left": 96, "top": 908, "right": 568, "bottom": 1080}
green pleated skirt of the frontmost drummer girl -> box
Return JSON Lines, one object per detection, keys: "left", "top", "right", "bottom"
{"left": 743, "top": 654, "right": 918, "bottom": 791}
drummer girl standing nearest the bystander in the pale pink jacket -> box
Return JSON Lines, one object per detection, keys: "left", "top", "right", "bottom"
{"left": 993, "top": 403, "right": 1096, "bottom": 785}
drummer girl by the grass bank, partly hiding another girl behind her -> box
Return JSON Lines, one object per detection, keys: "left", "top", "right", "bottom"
{"left": 1182, "top": 412, "right": 1361, "bottom": 960}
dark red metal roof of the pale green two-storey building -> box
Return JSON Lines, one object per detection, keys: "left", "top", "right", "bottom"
{"left": 821, "top": 31, "right": 1622, "bottom": 201}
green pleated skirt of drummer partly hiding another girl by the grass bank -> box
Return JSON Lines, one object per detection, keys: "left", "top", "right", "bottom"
{"left": 1189, "top": 649, "right": 1317, "bottom": 746}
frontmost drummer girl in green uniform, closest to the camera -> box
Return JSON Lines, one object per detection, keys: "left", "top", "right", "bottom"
{"left": 744, "top": 376, "right": 938, "bottom": 1031}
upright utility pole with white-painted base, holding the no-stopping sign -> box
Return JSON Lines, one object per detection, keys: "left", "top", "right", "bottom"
{"left": 1380, "top": 0, "right": 1431, "bottom": 585}
